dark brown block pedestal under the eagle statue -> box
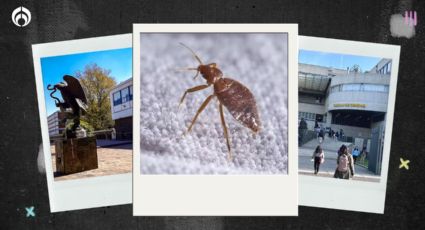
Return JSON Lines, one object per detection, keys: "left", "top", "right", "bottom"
{"left": 55, "top": 137, "right": 98, "bottom": 174}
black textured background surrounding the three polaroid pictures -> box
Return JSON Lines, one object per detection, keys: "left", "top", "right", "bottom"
{"left": 0, "top": 0, "right": 425, "bottom": 229}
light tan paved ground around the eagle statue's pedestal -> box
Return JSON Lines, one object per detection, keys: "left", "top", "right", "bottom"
{"left": 50, "top": 144, "right": 133, "bottom": 181}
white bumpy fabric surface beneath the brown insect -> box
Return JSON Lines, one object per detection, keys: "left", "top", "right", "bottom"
{"left": 140, "top": 34, "right": 288, "bottom": 174}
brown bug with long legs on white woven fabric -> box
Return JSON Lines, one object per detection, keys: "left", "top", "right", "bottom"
{"left": 179, "top": 43, "right": 261, "bottom": 160}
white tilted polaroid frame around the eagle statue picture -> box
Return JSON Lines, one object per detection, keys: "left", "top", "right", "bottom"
{"left": 32, "top": 34, "right": 132, "bottom": 212}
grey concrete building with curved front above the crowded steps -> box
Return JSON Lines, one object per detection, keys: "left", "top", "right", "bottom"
{"left": 298, "top": 59, "right": 391, "bottom": 174}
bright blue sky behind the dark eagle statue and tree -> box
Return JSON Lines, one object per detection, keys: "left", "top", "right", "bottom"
{"left": 41, "top": 48, "right": 133, "bottom": 116}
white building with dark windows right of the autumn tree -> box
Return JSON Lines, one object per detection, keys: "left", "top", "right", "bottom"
{"left": 109, "top": 78, "right": 133, "bottom": 140}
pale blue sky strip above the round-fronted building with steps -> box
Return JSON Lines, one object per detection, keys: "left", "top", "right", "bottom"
{"left": 299, "top": 50, "right": 382, "bottom": 71}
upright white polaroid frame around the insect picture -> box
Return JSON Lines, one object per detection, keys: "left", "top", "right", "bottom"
{"left": 133, "top": 24, "right": 298, "bottom": 216}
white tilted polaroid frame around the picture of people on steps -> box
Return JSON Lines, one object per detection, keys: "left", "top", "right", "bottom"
{"left": 299, "top": 36, "right": 400, "bottom": 214}
